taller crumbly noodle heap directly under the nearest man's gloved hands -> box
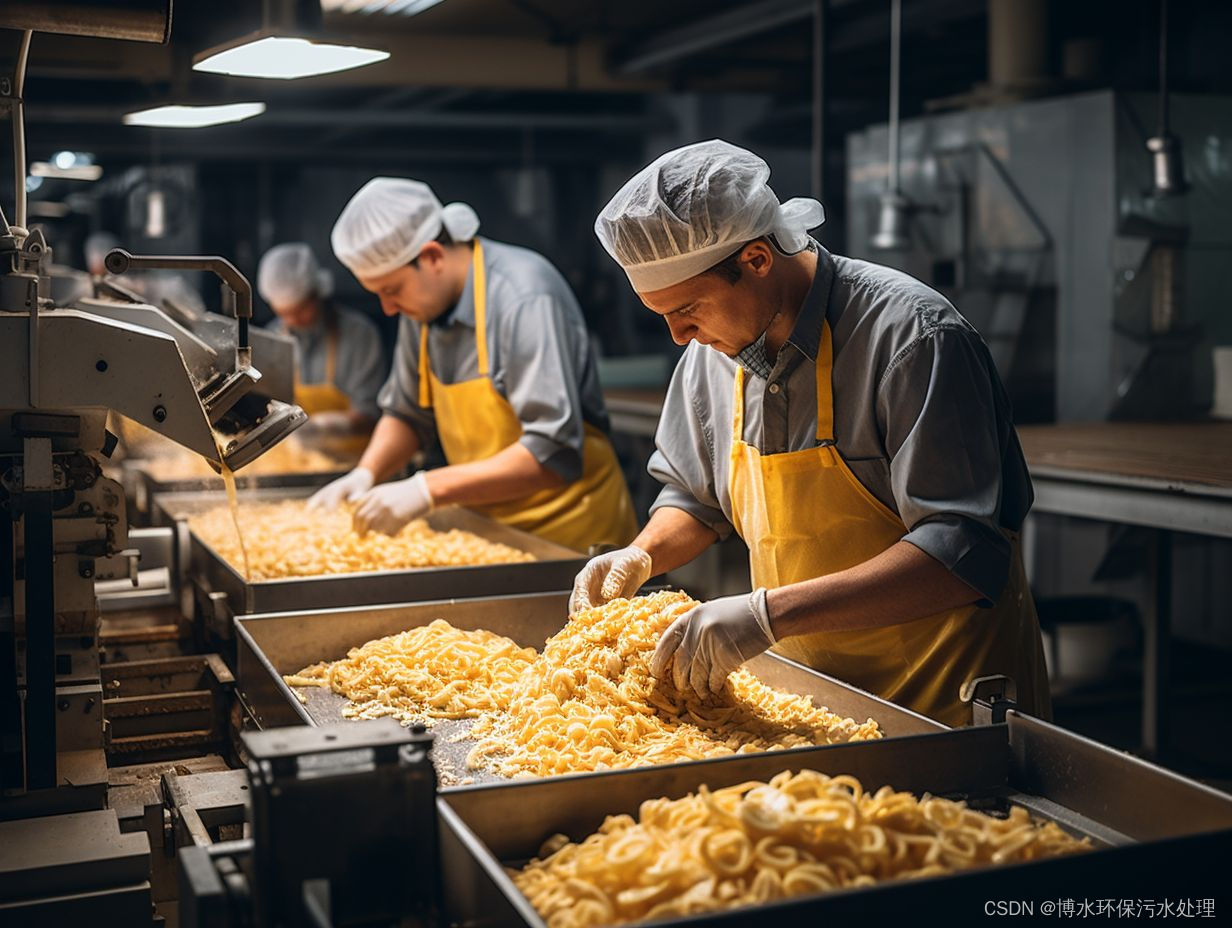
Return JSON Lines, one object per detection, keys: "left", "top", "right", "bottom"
{"left": 467, "top": 592, "right": 881, "bottom": 776}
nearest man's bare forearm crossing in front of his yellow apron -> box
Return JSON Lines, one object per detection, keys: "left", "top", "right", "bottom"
{"left": 766, "top": 541, "right": 979, "bottom": 638}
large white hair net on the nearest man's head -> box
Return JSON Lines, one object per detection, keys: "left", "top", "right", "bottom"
{"left": 595, "top": 139, "right": 825, "bottom": 293}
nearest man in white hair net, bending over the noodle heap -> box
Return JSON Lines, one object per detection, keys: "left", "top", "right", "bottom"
{"left": 570, "top": 140, "right": 1050, "bottom": 725}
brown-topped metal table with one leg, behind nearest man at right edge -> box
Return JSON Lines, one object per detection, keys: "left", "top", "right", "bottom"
{"left": 1018, "top": 421, "right": 1232, "bottom": 754}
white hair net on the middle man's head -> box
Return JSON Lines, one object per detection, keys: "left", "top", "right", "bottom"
{"left": 329, "top": 177, "right": 479, "bottom": 277}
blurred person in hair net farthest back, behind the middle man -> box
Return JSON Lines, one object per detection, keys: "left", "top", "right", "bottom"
{"left": 256, "top": 242, "right": 387, "bottom": 451}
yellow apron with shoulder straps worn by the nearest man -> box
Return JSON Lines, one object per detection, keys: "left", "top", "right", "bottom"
{"left": 729, "top": 324, "right": 1051, "bottom": 726}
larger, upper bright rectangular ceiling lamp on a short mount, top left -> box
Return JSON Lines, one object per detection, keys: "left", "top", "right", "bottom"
{"left": 192, "top": 0, "right": 389, "bottom": 80}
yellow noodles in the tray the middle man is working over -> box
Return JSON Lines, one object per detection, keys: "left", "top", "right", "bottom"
{"left": 188, "top": 500, "right": 535, "bottom": 580}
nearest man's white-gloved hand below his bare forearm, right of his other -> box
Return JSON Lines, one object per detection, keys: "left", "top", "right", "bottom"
{"left": 650, "top": 587, "right": 775, "bottom": 698}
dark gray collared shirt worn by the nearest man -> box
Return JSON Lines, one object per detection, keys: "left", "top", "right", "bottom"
{"left": 649, "top": 249, "right": 1032, "bottom": 605}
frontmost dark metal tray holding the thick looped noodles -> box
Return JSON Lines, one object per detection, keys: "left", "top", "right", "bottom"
{"left": 437, "top": 712, "right": 1232, "bottom": 928}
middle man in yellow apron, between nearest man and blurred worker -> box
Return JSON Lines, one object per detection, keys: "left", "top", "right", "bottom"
{"left": 310, "top": 177, "right": 637, "bottom": 551}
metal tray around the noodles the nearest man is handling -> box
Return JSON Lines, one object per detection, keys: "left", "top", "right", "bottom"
{"left": 235, "top": 593, "right": 945, "bottom": 786}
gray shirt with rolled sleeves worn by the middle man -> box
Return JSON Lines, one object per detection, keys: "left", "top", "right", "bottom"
{"left": 381, "top": 239, "right": 607, "bottom": 483}
